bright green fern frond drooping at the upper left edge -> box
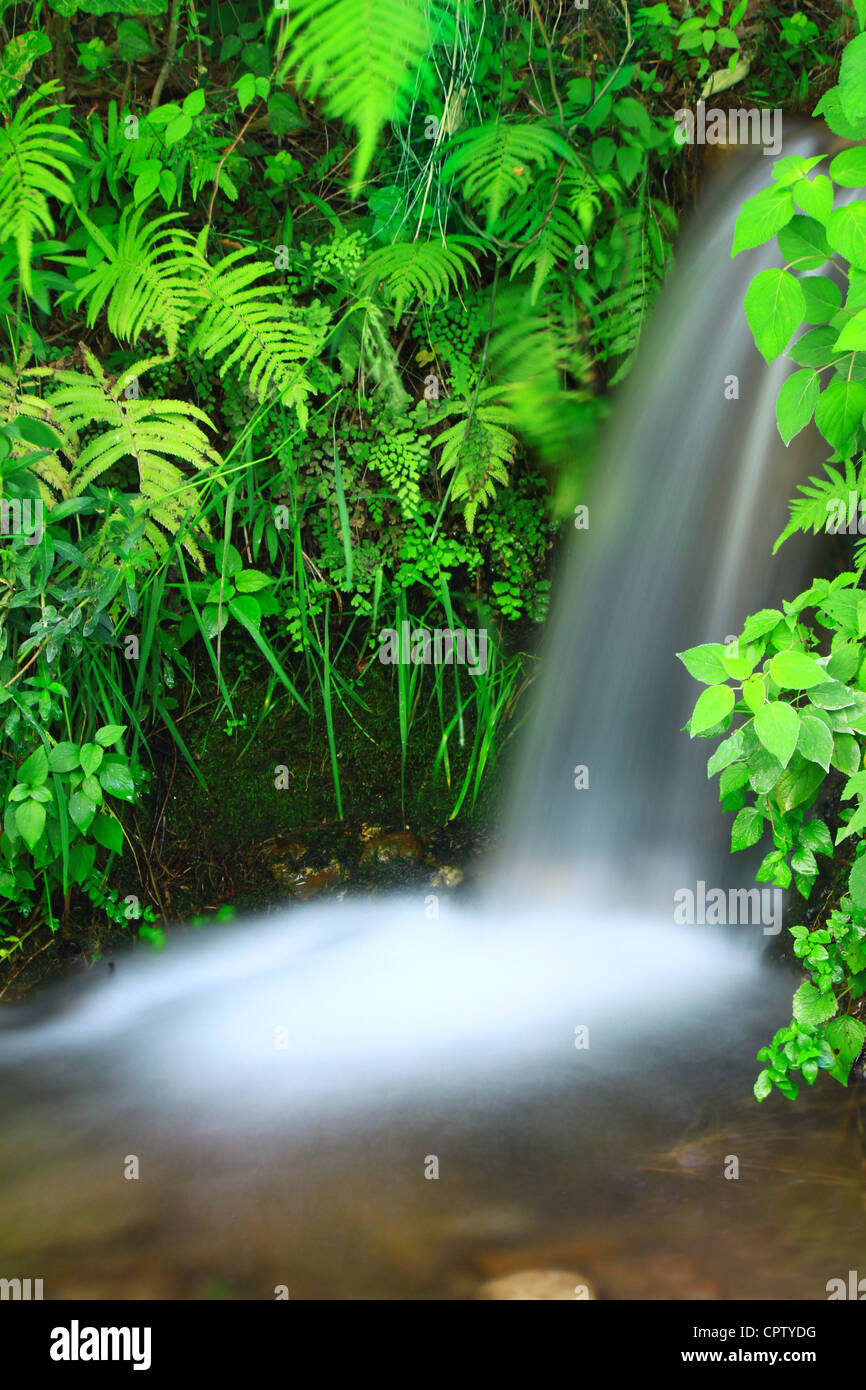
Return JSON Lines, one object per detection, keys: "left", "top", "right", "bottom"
{"left": 0, "top": 82, "right": 81, "bottom": 295}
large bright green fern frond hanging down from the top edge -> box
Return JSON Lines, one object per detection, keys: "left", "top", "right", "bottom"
{"left": 277, "top": 0, "right": 432, "bottom": 188}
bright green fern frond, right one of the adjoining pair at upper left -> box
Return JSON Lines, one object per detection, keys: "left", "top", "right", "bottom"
{"left": 190, "top": 249, "right": 327, "bottom": 424}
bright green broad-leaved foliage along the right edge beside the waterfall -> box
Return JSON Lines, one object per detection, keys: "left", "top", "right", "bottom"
{"left": 681, "top": 21, "right": 866, "bottom": 1099}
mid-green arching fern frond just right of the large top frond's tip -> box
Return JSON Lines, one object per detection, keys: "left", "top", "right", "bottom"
{"left": 442, "top": 121, "right": 574, "bottom": 231}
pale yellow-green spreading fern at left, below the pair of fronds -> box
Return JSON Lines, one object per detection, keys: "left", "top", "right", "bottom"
{"left": 47, "top": 343, "right": 221, "bottom": 566}
